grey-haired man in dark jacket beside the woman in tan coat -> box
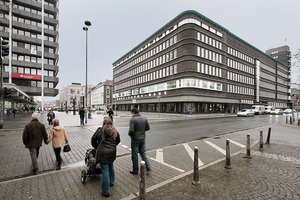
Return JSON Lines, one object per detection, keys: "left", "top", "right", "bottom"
{"left": 23, "top": 112, "right": 48, "bottom": 173}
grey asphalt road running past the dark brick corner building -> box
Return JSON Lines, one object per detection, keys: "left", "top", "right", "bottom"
{"left": 103, "top": 115, "right": 283, "bottom": 150}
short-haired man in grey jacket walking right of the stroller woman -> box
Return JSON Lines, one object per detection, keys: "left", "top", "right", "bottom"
{"left": 128, "top": 108, "right": 151, "bottom": 175}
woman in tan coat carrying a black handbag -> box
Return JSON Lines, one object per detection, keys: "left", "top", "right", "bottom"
{"left": 47, "top": 119, "right": 68, "bottom": 170}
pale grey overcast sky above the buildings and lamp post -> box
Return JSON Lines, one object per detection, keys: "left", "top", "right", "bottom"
{"left": 57, "top": 0, "right": 300, "bottom": 93}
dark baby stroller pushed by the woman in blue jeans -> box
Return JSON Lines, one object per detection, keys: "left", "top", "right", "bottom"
{"left": 81, "top": 149, "right": 102, "bottom": 184}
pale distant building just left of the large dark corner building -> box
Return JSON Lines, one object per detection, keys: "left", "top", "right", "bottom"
{"left": 91, "top": 80, "right": 113, "bottom": 110}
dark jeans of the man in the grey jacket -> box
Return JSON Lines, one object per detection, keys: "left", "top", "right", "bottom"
{"left": 131, "top": 139, "right": 151, "bottom": 172}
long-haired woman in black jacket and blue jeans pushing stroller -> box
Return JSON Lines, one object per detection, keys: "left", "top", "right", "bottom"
{"left": 96, "top": 118, "right": 120, "bottom": 197}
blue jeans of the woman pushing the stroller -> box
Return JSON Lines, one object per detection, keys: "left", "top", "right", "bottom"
{"left": 100, "top": 162, "right": 115, "bottom": 194}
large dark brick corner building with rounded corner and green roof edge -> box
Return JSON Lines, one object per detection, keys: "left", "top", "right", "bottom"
{"left": 113, "top": 11, "right": 290, "bottom": 113}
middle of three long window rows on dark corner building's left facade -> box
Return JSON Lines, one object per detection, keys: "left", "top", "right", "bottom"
{"left": 115, "top": 49, "right": 177, "bottom": 82}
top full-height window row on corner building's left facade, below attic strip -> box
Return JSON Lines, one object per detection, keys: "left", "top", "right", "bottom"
{"left": 115, "top": 35, "right": 177, "bottom": 74}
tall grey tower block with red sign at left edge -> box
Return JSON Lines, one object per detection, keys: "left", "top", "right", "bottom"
{"left": 0, "top": 0, "right": 59, "bottom": 99}
